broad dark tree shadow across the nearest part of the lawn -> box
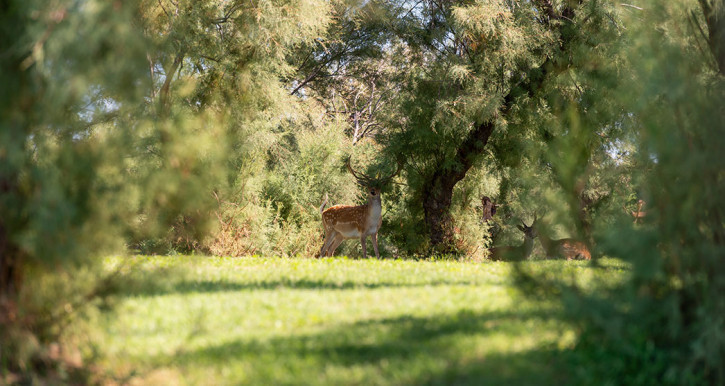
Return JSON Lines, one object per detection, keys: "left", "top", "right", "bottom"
{"left": 144, "top": 310, "right": 567, "bottom": 385}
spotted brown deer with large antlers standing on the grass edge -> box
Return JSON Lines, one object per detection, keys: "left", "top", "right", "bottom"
{"left": 318, "top": 158, "right": 402, "bottom": 259}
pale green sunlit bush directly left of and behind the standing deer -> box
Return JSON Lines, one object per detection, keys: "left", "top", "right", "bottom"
{"left": 209, "top": 102, "right": 360, "bottom": 256}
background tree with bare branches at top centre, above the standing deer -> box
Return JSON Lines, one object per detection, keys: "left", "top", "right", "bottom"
{"left": 288, "top": 2, "right": 399, "bottom": 145}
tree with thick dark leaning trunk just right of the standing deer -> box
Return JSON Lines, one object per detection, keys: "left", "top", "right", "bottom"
{"left": 376, "top": 1, "right": 616, "bottom": 251}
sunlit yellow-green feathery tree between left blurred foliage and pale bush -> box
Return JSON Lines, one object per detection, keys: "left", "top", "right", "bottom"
{"left": 133, "top": 0, "right": 329, "bottom": 251}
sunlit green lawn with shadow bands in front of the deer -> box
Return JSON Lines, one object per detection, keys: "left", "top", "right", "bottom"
{"left": 93, "top": 256, "right": 625, "bottom": 385}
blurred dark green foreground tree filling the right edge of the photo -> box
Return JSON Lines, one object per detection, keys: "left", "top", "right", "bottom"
{"left": 524, "top": 1, "right": 725, "bottom": 385}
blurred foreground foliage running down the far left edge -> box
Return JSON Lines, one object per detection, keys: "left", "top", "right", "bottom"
{"left": 0, "top": 1, "right": 153, "bottom": 382}
